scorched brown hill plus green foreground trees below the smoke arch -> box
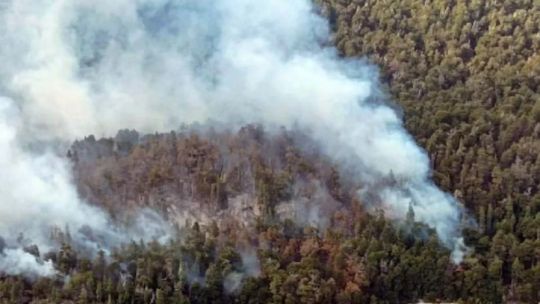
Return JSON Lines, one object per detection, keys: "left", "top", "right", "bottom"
{"left": 0, "top": 126, "right": 460, "bottom": 303}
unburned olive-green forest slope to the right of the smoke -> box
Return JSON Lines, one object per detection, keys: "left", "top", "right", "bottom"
{"left": 321, "top": 0, "right": 540, "bottom": 302}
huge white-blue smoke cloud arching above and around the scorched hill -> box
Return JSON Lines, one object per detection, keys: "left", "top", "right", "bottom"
{"left": 0, "top": 0, "right": 462, "bottom": 276}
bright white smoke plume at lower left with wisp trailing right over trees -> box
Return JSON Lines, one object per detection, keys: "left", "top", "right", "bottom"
{"left": 0, "top": 97, "right": 171, "bottom": 276}
